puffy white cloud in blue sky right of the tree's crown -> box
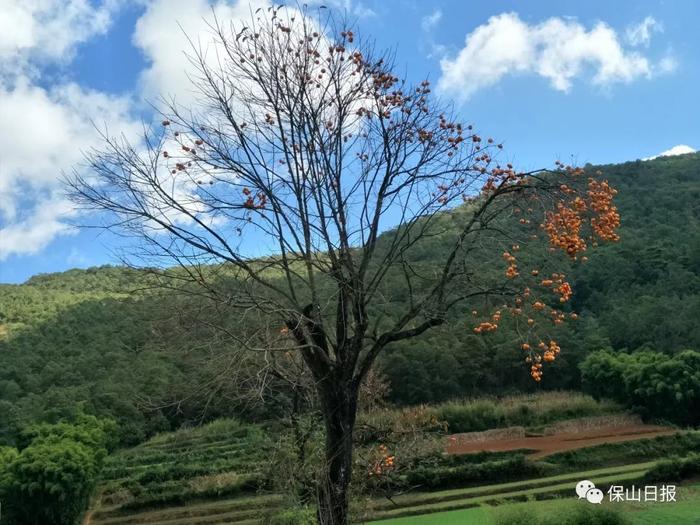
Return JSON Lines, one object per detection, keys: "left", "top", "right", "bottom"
{"left": 438, "top": 13, "right": 658, "bottom": 101}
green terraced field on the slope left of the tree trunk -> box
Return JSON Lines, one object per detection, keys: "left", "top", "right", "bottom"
{"left": 86, "top": 420, "right": 281, "bottom": 525}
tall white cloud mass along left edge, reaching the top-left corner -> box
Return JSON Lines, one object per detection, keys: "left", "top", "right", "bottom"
{"left": 0, "top": 0, "right": 139, "bottom": 260}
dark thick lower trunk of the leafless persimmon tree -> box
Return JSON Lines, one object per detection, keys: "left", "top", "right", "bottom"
{"left": 318, "top": 380, "right": 358, "bottom": 525}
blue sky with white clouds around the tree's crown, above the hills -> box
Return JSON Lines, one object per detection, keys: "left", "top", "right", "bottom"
{"left": 0, "top": 0, "right": 700, "bottom": 282}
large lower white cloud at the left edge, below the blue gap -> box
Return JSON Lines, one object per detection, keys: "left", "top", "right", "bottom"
{"left": 0, "top": 77, "right": 140, "bottom": 260}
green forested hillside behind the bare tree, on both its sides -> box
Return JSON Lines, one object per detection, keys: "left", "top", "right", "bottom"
{"left": 0, "top": 155, "right": 700, "bottom": 444}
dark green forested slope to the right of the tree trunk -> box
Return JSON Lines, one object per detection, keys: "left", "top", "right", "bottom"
{"left": 384, "top": 154, "right": 700, "bottom": 403}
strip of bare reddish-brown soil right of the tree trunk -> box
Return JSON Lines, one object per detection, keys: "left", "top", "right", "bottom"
{"left": 447, "top": 424, "right": 676, "bottom": 459}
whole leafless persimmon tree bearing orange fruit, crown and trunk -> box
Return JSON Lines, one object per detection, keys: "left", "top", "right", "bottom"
{"left": 68, "top": 8, "right": 619, "bottom": 525}
